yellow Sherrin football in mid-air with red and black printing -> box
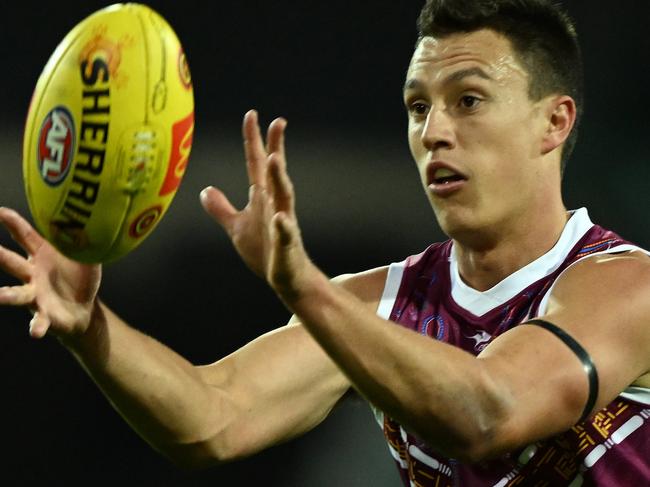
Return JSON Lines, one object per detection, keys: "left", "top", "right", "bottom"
{"left": 23, "top": 3, "right": 194, "bottom": 262}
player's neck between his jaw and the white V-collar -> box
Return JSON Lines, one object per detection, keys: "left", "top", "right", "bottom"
{"left": 454, "top": 205, "right": 569, "bottom": 291}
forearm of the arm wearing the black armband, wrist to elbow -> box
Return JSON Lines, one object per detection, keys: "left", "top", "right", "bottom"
{"left": 286, "top": 276, "right": 503, "bottom": 457}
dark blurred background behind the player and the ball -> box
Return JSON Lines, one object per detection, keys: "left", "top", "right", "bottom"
{"left": 0, "top": 0, "right": 650, "bottom": 487}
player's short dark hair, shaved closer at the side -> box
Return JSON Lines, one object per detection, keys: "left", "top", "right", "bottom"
{"left": 418, "top": 0, "right": 584, "bottom": 172}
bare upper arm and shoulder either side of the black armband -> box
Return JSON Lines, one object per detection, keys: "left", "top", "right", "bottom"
{"left": 479, "top": 254, "right": 650, "bottom": 456}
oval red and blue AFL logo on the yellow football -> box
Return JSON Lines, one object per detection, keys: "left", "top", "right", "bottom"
{"left": 37, "top": 106, "right": 75, "bottom": 186}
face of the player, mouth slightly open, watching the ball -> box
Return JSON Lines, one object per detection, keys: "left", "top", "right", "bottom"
{"left": 404, "top": 30, "right": 547, "bottom": 242}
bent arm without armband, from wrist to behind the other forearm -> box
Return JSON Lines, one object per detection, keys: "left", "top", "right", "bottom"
{"left": 68, "top": 304, "right": 349, "bottom": 466}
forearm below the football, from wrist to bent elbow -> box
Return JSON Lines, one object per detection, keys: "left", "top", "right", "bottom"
{"left": 64, "top": 303, "right": 234, "bottom": 463}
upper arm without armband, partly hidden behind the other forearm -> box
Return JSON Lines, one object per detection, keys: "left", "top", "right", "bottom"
{"left": 191, "top": 268, "right": 386, "bottom": 459}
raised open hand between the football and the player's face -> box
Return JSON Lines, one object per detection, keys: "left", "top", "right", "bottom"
{"left": 201, "top": 110, "right": 318, "bottom": 301}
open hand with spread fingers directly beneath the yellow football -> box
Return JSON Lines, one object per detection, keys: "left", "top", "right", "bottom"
{"left": 0, "top": 208, "right": 101, "bottom": 340}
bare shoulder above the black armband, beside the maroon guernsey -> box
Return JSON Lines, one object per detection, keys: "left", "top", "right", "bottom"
{"left": 547, "top": 251, "right": 650, "bottom": 398}
